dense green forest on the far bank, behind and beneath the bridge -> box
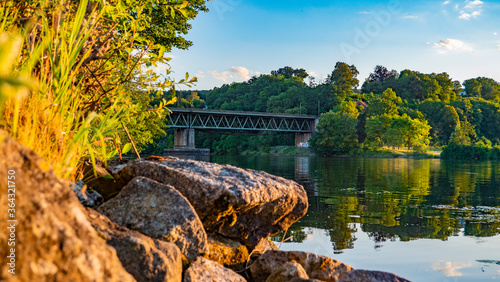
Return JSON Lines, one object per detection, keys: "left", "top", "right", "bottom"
{"left": 150, "top": 62, "right": 500, "bottom": 158}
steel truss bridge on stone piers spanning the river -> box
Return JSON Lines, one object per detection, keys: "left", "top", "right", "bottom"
{"left": 166, "top": 108, "right": 318, "bottom": 148}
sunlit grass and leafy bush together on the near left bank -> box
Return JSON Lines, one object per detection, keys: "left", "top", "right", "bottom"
{"left": 0, "top": 0, "right": 203, "bottom": 179}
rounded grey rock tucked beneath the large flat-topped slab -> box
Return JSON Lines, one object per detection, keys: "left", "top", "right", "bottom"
{"left": 97, "top": 177, "right": 208, "bottom": 261}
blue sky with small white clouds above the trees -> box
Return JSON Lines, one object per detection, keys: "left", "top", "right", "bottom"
{"left": 163, "top": 0, "right": 500, "bottom": 90}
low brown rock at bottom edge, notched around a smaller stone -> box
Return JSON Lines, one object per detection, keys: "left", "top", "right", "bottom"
{"left": 250, "top": 251, "right": 353, "bottom": 281}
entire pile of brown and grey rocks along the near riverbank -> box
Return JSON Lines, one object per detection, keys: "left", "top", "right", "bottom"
{"left": 0, "top": 131, "right": 408, "bottom": 282}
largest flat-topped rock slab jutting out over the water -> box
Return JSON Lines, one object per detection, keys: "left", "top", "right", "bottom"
{"left": 109, "top": 159, "right": 308, "bottom": 247}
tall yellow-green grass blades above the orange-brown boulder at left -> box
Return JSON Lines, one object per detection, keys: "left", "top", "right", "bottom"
{"left": 0, "top": 0, "right": 124, "bottom": 179}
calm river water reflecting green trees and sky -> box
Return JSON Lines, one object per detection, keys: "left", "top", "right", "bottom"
{"left": 212, "top": 156, "right": 500, "bottom": 281}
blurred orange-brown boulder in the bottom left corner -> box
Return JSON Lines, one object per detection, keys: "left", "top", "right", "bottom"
{"left": 0, "top": 131, "right": 135, "bottom": 281}
